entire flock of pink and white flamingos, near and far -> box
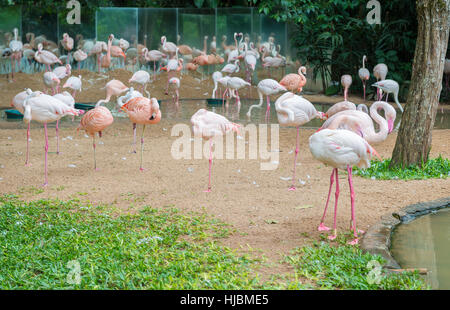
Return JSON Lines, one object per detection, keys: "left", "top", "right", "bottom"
{"left": 5, "top": 29, "right": 412, "bottom": 244}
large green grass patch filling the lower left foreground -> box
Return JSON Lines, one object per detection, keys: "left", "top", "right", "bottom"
{"left": 0, "top": 195, "right": 294, "bottom": 290}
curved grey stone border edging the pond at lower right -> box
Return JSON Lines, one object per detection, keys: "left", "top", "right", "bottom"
{"left": 360, "top": 197, "right": 450, "bottom": 269}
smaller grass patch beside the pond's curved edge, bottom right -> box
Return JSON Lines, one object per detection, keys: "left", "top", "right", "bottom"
{"left": 285, "top": 242, "right": 429, "bottom": 290}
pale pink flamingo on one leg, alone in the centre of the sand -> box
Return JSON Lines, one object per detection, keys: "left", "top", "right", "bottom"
{"left": 191, "top": 109, "right": 240, "bottom": 192}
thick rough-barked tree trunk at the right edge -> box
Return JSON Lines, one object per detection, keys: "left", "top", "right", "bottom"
{"left": 391, "top": 0, "right": 450, "bottom": 167}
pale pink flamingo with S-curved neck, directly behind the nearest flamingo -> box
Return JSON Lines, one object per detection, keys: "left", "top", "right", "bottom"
{"left": 321, "top": 101, "right": 397, "bottom": 144}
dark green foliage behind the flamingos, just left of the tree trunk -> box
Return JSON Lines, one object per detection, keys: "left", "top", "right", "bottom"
{"left": 252, "top": 0, "right": 417, "bottom": 98}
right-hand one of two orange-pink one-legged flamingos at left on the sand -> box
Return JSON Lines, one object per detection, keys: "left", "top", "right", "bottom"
{"left": 121, "top": 97, "right": 161, "bottom": 171}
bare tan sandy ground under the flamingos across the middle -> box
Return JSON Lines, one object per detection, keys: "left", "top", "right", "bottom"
{"left": 0, "top": 114, "right": 450, "bottom": 274}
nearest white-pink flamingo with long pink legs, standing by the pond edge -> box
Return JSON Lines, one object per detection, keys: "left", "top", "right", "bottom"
{"left": 309, "top": 129, "right": 379, "bottom": 245}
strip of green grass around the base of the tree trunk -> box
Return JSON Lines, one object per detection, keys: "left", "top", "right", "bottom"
{"left": 354, "top": 156, "right": 450, "bottom": 180}
